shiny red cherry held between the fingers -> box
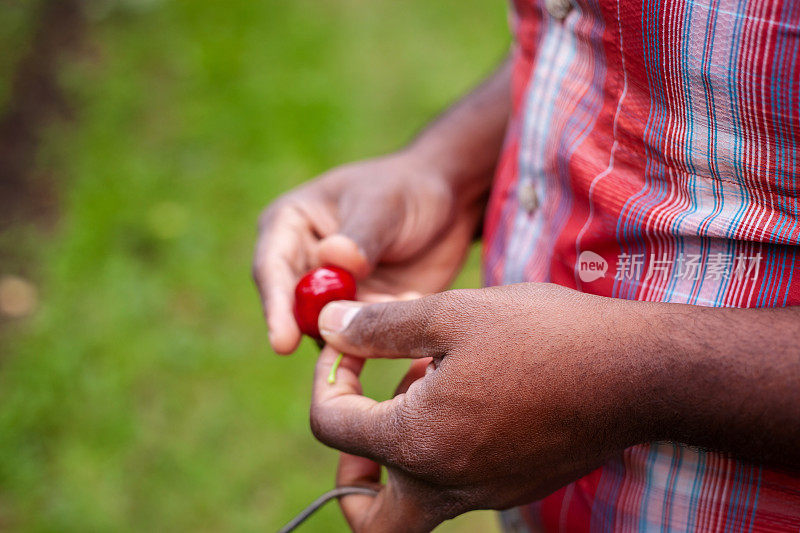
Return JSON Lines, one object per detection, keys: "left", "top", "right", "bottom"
{"left": 294, "top": 266, "right": 356, "bottom": 339}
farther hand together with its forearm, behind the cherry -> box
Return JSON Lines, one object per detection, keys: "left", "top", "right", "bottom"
{"left": 253, "top": 58, "right": 511, "bottom": 354}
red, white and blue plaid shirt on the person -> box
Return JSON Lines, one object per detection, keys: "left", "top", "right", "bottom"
{"left": 484, "top": 0, "right": 800, "bottom": 531}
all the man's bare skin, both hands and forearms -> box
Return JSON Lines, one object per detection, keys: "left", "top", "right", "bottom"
{"left": 254, "top": 56, "right": 800, "bottom": 532}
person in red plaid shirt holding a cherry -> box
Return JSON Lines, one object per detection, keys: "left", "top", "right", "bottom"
{"left": 254, "top": 0, "right": 800, "bottom": 532}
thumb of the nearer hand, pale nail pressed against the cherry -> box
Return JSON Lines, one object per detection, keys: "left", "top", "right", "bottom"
{"left": 319, "top": 297, "right": 449, "bottom": 358}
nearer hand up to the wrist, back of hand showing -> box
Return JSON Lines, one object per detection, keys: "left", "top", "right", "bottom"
{"left": 311, "top": 284, "right": 650, "bottom": 532}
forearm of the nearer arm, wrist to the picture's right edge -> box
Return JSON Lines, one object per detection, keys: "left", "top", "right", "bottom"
{"left": 626, "top": 302, "right": 800, "bottom": 468}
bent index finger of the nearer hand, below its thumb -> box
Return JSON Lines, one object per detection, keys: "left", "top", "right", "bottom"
{"left": 311, "top": 346, "right": 404, "bottom": 464}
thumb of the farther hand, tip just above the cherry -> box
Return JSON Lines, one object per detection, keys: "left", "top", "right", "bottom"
{"left": 318, "top": 188, "right": 402, "bottom": 279}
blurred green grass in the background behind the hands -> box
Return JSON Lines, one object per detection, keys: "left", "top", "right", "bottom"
{"left": 0, "top": 0, "right": 508, "bottom": 531}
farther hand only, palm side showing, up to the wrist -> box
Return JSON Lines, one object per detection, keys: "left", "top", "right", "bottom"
{"left": 253, "top": 153, "right": 482, "bottom": 353}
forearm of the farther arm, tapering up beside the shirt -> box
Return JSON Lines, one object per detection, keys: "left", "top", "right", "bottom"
{"left": 405, "top": 55, "right": 511, "bottom": 208}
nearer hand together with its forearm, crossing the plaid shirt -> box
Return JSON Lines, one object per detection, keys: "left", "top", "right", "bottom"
{"left": 311, "top": 283, "right": 800, "bottom": 532}
